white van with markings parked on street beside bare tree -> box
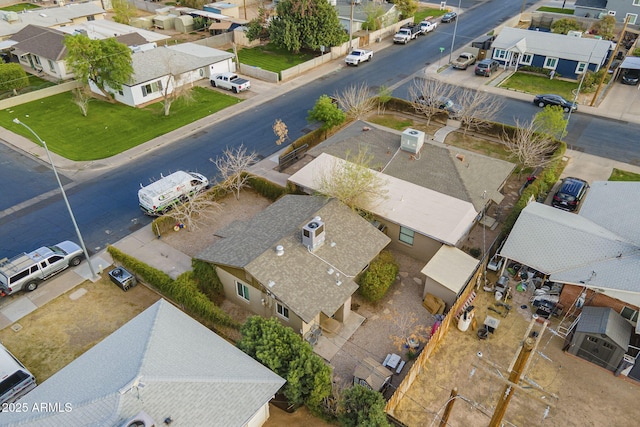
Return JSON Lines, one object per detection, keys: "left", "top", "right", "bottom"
{"left": 138, "top": 171, "right": 209, "bottom": 216}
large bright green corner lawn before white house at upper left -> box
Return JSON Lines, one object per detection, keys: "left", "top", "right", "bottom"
{"left": 0, "top": 87, "right": 240, "bottom": 161}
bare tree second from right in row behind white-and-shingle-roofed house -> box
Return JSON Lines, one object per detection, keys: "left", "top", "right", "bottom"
{"left": 457, "top": 88, "right": 504, "bottom": 135}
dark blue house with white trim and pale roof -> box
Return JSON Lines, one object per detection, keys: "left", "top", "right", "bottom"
{"left": 491, "top": 27, "right": 615, "bottom": 79}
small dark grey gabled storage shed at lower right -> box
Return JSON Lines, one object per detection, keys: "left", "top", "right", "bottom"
{"left": 568, "top": 306, "right": 633, "bottom": 372}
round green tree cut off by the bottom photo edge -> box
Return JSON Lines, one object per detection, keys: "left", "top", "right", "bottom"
{"left": 338, "top": 385, "right": 390, "bottom": 427}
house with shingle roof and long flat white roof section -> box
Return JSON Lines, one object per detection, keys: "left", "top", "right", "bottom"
{"left": 289, "top": 121, "right": 515, "bottom": 263}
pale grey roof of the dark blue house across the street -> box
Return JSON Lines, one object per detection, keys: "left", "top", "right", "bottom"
{"left": 491, "top": 27, "right": 613, "bottom": 64}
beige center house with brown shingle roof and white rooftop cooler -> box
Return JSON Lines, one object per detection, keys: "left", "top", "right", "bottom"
{"left": 196, "top": 195, "right": 389, "bottom": 344}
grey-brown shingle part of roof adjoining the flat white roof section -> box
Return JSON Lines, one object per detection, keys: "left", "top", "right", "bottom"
{"left": 308, "top": 121, "right": 515, "bottom": 212}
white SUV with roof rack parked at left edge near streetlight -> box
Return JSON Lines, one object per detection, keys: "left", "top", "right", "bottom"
{"left": 0, "top": 240, "right": 83, "bottom": 296}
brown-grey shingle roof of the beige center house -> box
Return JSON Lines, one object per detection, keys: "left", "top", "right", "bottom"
{"left": 196, "top": 195, "right": 390, "bottom": 322}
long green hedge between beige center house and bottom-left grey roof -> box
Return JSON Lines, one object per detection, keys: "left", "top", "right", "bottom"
{"left": 107, "top": 246, "right": 240, "bottom": 329}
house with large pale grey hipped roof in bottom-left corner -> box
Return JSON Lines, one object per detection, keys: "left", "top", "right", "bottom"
{"left": 2, "top": 300, "right": 285, "bottom": 427}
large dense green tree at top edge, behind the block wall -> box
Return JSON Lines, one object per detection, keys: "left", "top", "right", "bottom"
{"left": 269, "top": 0, "right": 347, "bottom": 53}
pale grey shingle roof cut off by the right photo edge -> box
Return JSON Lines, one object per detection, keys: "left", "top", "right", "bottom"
{"left": 500, "top": 182, "right": 640, "bottom": 299}
